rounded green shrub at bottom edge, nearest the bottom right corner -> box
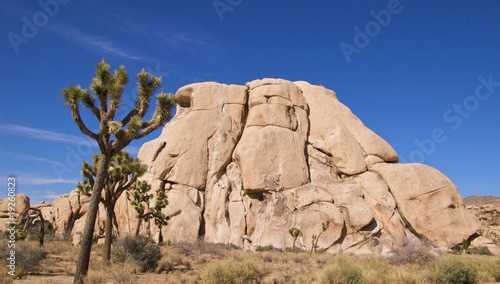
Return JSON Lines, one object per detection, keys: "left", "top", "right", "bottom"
{"left": 428, "top": 256, "right": 478, "bottom": 284}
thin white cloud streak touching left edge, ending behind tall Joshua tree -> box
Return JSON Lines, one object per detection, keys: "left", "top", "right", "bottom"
{"left": 0, "top": 123, "right": 95, "bottom": 145}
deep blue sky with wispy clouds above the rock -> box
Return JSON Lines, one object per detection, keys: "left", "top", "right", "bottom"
{"left": 0, "top": 0, "right": 500, "bottom": 203}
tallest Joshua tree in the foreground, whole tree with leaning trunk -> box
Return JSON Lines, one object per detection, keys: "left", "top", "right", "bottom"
{"left": 62, "top": 60, "right": 175, "bottom": 284}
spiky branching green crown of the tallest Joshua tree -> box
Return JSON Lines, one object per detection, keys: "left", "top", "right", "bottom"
{"left": 62, "top": 60, "right": 176, "bottom": 156}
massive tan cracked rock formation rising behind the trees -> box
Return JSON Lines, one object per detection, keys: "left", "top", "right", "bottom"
{"left": 129, "top": 79, "right": 479, "bottom": 253}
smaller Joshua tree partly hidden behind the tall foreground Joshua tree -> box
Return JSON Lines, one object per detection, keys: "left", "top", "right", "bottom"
{"left": 77, "top": 151, "right": 147, "bottom": 264}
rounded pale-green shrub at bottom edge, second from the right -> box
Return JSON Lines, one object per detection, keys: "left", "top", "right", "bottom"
{"left": 321, "top": 257, "right": 368, "bottom": 284}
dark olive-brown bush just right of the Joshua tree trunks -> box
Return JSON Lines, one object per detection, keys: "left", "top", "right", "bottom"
{"left": 112, "top": 235, "right": 161, "bottom": 272}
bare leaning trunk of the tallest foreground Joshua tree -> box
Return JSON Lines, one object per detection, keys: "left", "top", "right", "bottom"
{"left": 73, "top": 154, "right": 110, "bottom": 284}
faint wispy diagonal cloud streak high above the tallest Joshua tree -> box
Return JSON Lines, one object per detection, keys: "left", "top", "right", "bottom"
{"left": 48, "top": 23, "right": 142, "bottom": 60}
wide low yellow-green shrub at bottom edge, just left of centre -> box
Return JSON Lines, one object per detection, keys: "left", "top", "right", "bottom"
{"left": 201, "top": 259, "right": 265, "bottom": 284}
